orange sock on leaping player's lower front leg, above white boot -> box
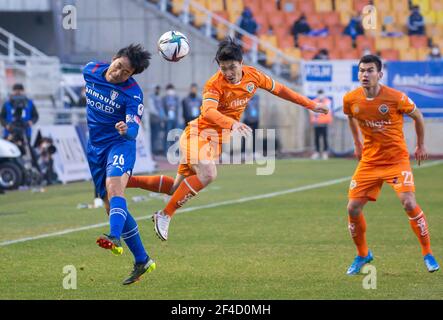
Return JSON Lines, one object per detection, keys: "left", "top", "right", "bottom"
{"left": 163, "top": 175, "right": 205, "bottom": 217}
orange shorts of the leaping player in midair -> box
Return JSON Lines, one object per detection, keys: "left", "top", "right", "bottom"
{"left": 177, "top": 126, "right": 222, "bottom": 177}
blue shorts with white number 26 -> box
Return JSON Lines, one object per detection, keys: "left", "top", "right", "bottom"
{"left": 87, "top": 140, "right": 136, "bottom": 198}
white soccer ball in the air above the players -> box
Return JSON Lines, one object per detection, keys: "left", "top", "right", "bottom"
{"left": 157, "top": 31, "right": 189, "bottom": 62}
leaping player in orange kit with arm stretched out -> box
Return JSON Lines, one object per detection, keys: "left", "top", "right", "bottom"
{"left": 128, "top": 38, "right": 328, "bottom": 241}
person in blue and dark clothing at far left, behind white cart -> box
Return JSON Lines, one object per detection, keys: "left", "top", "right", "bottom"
{"left": 0, "top": 83, "right": 38, "bottom": 143}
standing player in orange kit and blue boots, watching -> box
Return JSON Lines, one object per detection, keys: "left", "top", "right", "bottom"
{"left": 343, "top": 55, "right": 439, "bottom": 275}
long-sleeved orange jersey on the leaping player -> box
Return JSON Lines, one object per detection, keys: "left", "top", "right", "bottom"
{"left": 189, "top": 65, "right": 315, "bottom": 142}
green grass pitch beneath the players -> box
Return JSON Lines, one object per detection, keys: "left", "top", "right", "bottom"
{"left": 0, "top": 160, "right": 443, "bottom": 299}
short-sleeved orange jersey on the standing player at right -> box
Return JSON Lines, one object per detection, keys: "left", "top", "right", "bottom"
{"left": 343, "top": 85, "right": 416, "bottom": 165}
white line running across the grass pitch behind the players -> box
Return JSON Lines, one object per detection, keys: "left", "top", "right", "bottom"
{"left": 0, "top": 160, "right": 443, "bottom": 247}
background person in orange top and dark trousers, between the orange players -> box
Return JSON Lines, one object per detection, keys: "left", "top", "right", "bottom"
{"left": 309, "top": 89, "right": 332, "bottom": 160}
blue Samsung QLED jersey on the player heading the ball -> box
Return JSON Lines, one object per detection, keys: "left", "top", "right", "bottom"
{"left": 83, "top": 61, "right": 143, "bottom": 147}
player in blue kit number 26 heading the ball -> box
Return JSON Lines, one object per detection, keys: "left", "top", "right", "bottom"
{"left": 83, "top": 45, "right": 155, "bottom": 285}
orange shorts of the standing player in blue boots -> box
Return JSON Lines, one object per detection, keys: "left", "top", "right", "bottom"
{"left": 348, "top": 161, "right": 415, "bottom": 201}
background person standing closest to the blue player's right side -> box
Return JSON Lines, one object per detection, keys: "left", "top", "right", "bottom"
{"left": 148, "top": 85, "right": 166, "bottom": 154}
